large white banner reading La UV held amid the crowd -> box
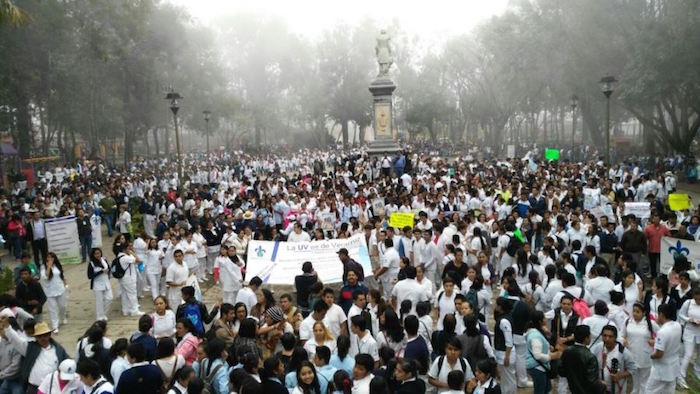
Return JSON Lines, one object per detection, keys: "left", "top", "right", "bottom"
{"left": 246, "top": 234, "right": 372, "bottom": 285}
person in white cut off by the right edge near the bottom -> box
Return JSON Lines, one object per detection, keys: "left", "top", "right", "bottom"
{"left": 678, "top": 288, "right": 700, "bottom": 389}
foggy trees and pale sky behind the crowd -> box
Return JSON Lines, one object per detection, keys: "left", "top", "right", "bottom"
{"left": 0, "top": 0, "right": 700, "bottom": 161}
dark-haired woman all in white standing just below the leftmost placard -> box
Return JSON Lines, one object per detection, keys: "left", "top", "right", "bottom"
{"left": 41, "top": 252, "right": 68, "bottom": 333}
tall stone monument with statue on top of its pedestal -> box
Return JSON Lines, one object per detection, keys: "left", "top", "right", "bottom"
{"left": 368, "top": 30, "right": 401, "bottom": 156}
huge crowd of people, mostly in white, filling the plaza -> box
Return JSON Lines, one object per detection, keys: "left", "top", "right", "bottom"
{"left": 0, "top": 149, "right": 700, "bottom": 394}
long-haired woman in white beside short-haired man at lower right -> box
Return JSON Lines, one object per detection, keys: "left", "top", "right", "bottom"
{"left": 622, "top": 302, "right": 659, "bottom": 394}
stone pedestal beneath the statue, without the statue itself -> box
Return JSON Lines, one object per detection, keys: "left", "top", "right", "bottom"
{"left": 367, "top": 75, "right": 401, "bottom": 156}
